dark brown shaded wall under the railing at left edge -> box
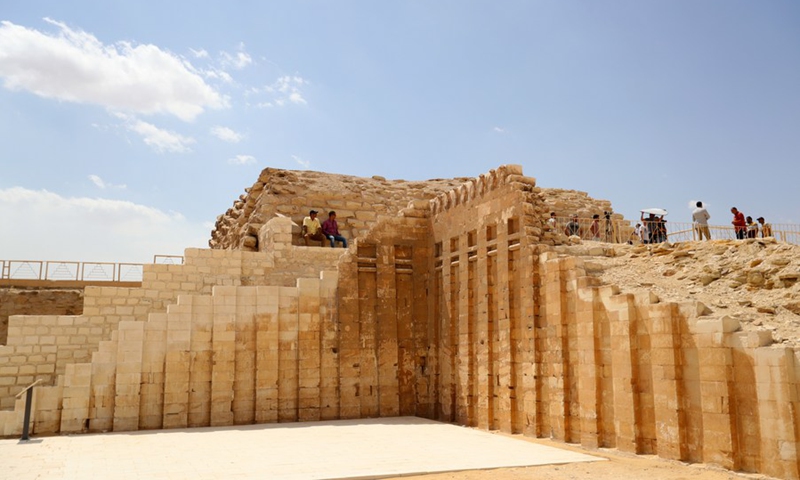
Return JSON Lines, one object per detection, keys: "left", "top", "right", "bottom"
{"left": 0, "top": 287, "right": 83, "bottom": 345}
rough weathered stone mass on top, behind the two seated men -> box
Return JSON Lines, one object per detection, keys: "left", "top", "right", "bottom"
{"left": 208, "top": 165, "right": 629, "bottom": 251}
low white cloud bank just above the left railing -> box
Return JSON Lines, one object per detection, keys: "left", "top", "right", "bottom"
{"left": 0, "top": 187, "right": 210, "bottom": 263}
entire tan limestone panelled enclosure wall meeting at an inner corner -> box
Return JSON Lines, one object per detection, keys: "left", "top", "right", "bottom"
{"left": 0, "top": 166, "right": 800, "bottom": 478}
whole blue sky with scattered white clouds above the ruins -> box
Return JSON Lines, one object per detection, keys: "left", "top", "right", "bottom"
{"left": 0, "top": 0, "right": 800, "bottom": 262}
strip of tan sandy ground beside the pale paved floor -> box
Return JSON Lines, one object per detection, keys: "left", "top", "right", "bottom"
{"left": 402, "top": 437, "right": 772, "bottom": 480}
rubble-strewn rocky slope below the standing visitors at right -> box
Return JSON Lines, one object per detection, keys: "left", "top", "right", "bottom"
{"left": 558, "top": 238, "right": 800, "bottom": 346}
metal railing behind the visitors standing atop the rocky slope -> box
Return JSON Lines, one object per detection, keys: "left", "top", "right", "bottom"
{"left": 550, "top": 216, "right": 800, "bottom": 245}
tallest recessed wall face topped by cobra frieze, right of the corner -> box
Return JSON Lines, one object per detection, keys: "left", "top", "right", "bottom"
{"left": 424, "top": 166, "right": 544, "bottom": 431}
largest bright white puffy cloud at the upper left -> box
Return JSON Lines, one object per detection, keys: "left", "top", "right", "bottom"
{"left": 0, "top": 18, "right": 228, "bottom": 121}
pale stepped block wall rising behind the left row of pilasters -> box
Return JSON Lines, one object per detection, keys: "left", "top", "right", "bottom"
{"left": 0, "top": 246, "right": 343, "bottom": 408}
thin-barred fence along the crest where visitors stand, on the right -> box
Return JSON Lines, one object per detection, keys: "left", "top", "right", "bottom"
{"left": 547, "top": 216, "right": 800, "bottom": 245}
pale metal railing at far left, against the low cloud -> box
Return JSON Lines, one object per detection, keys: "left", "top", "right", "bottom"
{"left": 0, "top": 255, "right": 183, "bottom": 282}
